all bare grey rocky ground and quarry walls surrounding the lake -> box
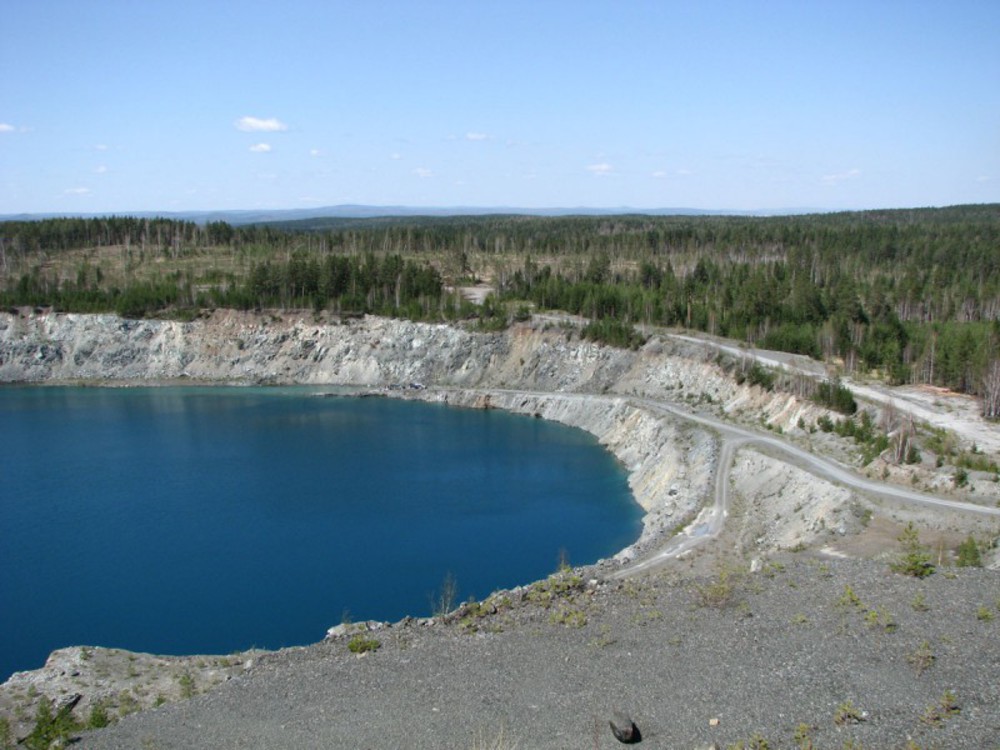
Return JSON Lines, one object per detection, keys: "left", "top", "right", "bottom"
{"left": 0, "top": 311, "right": 1000, "bottom": 750}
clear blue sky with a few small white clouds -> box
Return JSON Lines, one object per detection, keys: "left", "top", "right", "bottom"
{"left": 0, "top": 0, "right": 1000, "bottom": 213}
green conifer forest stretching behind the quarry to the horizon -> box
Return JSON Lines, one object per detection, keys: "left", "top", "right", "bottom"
{"left": 0, "top": 204, "right": 1000, "bottom": 416}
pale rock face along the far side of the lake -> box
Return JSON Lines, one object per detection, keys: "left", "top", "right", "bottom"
{"left": 0, "top": 311, "right": 748, "bottom": 400}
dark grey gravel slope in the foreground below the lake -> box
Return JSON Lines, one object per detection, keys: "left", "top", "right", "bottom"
{"left": 78, "top": 554, "right": 1000, "bottom": 750}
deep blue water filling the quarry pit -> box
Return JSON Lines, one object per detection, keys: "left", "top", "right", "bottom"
{"left": 0, "top": 387, "right": 641, "bottom": 680}
